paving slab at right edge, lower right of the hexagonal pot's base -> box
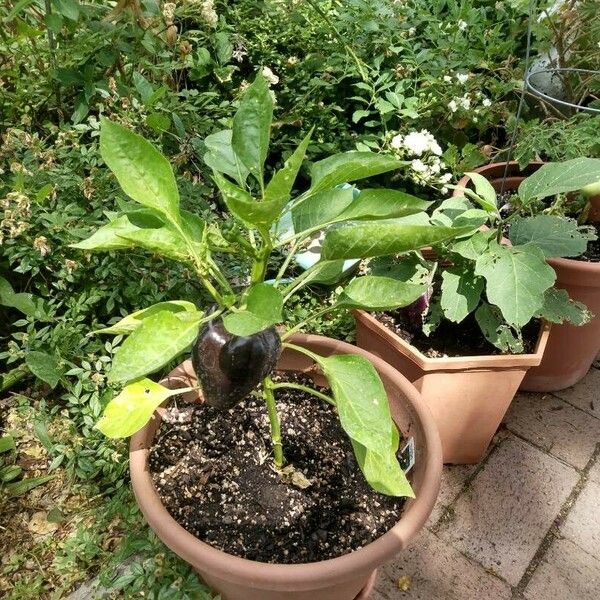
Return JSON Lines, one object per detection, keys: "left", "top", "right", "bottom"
{"left": 504, "top": 392, "right": 600, "bottom": 469}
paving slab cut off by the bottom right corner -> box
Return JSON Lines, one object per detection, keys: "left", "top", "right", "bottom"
{"left": 524, "top": 540, "right": 600, "bottom": 600}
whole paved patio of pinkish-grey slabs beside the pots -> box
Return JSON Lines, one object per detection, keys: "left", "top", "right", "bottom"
{"left": 371, "top": 357, "right": 600, "bottom": 600}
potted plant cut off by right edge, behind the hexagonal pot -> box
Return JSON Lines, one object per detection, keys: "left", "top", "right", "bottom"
{"left": 455, "top": 157, "right": 600, "bottom": 392}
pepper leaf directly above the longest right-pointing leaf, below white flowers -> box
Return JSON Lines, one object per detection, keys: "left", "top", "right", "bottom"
{"left": 336, "top": 188, "right": 431, "bottom": 221}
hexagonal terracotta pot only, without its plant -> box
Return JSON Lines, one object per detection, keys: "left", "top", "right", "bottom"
{"left": 355, "top": 311, "right": 550, "bottom": 464}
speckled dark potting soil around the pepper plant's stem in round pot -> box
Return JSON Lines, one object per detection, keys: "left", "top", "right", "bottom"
{"left": 149, "top": 373, "right": 404, "bottom": 564}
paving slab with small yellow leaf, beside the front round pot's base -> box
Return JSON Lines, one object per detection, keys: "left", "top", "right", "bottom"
{"left": 370, "top": 530, "right": 512, "bottom": 600}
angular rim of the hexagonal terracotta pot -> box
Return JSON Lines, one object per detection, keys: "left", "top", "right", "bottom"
{"left": 354, "top": 310, "right": 552, "bottom": 371}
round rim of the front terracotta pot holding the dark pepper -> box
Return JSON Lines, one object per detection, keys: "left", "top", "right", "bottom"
{"left": 129, "top": 334, "right": 442, "bottom": 590}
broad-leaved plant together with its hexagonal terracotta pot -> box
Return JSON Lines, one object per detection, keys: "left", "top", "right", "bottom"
{"left": 356, "top": 168, "right": 587, "bottom": 463}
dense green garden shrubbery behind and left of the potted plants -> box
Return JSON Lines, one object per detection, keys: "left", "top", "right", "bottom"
{"left": 0, "top": 0, "right": 600, "bottom": 599}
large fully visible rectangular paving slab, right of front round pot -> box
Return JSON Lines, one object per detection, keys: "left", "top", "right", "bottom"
{"left": 440, "top": 436, "right": 579, "bottom": 585}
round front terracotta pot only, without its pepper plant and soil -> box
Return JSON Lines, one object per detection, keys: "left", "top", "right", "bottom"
{"left": 130, "top": 334, "right": 442, "bottom": 600}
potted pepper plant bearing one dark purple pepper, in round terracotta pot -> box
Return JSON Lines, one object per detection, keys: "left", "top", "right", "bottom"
{"left": 75, "top": 76, "right": 471, "bottom": 600}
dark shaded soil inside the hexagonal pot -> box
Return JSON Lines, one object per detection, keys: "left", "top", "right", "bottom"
{"left": 374, "top": 311, "right": 540, "bottom": 358}
